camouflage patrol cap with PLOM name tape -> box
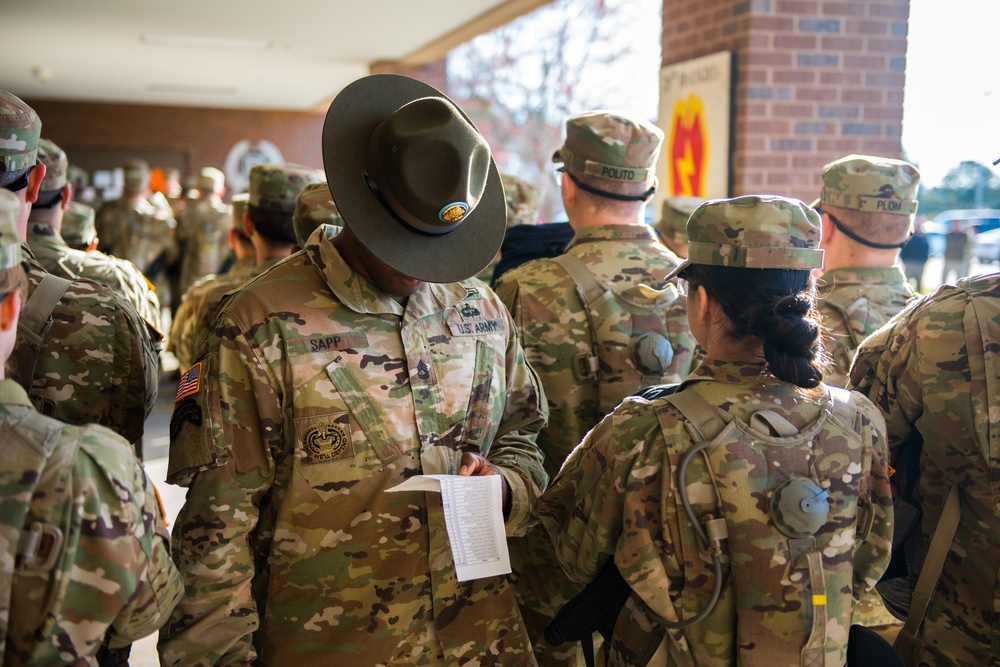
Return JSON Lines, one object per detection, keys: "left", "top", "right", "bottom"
{"left": 812, "top": 155, "right": 920, "bottom": 215}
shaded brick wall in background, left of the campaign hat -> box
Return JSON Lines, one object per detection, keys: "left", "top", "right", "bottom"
{"left": 26, "top": 100, "right": 324, "bottom": 185}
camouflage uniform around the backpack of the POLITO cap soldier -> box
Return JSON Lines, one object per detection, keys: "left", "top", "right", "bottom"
{"left": 496, "top": 225, "right": 696, "bottom": 664}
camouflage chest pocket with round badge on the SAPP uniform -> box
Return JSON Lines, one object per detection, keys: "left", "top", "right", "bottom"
{"left": 294, "top": 411, "right": 383, "bottom": 500}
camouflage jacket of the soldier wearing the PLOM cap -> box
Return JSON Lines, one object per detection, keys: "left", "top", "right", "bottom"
{"left": 817, "top": 265, "right": 917, "bottom": 387}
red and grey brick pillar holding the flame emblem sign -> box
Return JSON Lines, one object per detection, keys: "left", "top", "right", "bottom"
{"left": 663, "top": 0, "right": 910, "bottom": 202}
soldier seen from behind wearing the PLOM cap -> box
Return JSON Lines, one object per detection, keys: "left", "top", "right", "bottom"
{"left": 812, "top": 155, "right": 920, "bottom": 387}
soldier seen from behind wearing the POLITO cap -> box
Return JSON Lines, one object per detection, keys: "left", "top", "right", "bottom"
{"left": 496, "top": 112, "right": 695, "bottom": 665}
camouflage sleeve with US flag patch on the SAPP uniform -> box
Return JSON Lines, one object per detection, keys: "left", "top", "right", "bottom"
{"left": 159, "top": 314, "right": 283, "bottom": 665}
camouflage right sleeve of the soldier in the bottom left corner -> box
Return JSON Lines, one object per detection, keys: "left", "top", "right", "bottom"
{"left": 71, "top": 427, "right": 183, "bottom": 648}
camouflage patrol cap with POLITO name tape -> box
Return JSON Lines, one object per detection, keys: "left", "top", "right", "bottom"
{"left": 552, "top": 111, "right": 663, "bottom": 201}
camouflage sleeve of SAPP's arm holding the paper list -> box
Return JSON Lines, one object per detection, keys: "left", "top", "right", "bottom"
{"left": 487, "top": 292, "right": 549, "bottom": 536}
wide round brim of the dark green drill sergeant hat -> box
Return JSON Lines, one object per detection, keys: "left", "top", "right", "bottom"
{"left": 323, "top": 74, "right": 507, "bottom": 283}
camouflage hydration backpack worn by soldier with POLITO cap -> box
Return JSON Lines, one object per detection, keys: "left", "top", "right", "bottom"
{"left": 553, "top": 254, "right": 680, "bottom": 420}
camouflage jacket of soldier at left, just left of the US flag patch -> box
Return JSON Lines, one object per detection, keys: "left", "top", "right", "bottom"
{"left": 8, "top": 245, "right": 160, "bottom": 443}
